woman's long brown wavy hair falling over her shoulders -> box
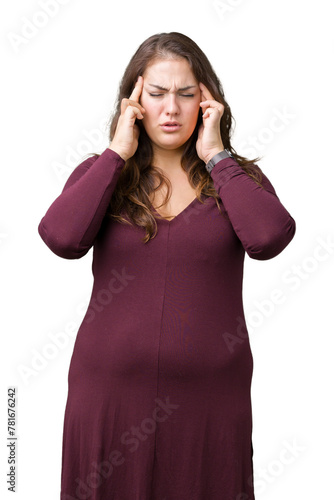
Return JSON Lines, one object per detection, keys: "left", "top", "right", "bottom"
{"left": 90, "top": 32, "right": 262, "bottom": 243}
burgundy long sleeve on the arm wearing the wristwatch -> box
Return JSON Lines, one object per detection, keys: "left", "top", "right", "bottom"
{"left": 211, "top": 158, "right": 296, "bottom": 260}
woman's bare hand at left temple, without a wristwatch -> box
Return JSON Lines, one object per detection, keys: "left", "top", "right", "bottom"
{"left": 109, "top": 76, "right": 145, "bottom": 161}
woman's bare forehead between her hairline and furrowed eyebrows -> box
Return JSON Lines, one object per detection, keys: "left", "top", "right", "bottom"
{"left": 143, "top": 58, "right": 197, "bottom": 87}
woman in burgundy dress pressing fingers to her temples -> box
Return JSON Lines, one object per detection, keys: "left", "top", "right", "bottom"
{"left": 38, "top": 32, "right": 295, "bottom": 500}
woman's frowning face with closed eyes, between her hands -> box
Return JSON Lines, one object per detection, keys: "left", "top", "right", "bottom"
{"left": 139, "top": 59, "right": 201, "bottom": 149}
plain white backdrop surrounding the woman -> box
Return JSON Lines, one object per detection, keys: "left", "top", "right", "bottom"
{"left": 0, "top": 0, "right": 334, "bottom": 500}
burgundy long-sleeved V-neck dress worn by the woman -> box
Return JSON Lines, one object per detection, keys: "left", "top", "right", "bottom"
{"left": 38, "top": 148, "right": 295, "bottom": 500}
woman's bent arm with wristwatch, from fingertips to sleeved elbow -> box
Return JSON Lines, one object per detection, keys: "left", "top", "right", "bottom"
{"left": 196, "top": 83, "right": 296, "bottom": 260}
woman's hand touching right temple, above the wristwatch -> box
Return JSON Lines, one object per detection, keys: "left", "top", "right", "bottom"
{"left": 196, "top": 82, "right": 225, "bottom": 163}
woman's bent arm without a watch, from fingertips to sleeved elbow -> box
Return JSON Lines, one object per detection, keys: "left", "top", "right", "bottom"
{"left": 38, "top": 76, "right": 145, "bottom": 259}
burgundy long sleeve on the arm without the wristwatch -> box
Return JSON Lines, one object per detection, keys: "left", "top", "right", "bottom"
{"left": 38, "top": 148, "right": 125, "bottom": 259}
